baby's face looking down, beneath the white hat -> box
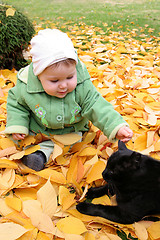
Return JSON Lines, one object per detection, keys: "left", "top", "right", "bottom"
{"left": 38, "top": 64, "right": 77, "bottom": 98}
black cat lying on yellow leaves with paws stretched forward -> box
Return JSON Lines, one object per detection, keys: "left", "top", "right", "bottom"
{"left": 76, "top": 141, "right": 160, "bottom": 224}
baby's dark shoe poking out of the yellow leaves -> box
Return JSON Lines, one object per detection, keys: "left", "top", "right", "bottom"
{"left": 22, "top": 151, "right": 46, "bottom": 171}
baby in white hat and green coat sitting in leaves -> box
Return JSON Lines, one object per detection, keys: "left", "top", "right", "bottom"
{"left": 5, "top": 29, "right": 133, "bottom": 171}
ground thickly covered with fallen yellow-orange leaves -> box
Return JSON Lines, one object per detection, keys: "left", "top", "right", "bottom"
{"left": 0, "top": 22, "right": 160, "bottom": 240}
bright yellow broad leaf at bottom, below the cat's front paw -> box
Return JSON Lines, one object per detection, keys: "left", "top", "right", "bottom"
{"left": 57, "top": 217, "right": 87, "bottom": 235}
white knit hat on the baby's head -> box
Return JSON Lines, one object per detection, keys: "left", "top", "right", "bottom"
{"left": 30, "top": 29, "right": 78, "bottom": 76}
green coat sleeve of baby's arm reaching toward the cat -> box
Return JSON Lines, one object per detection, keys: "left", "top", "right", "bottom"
{"left": 78, "top": 80, "right": 128, "bottom": 142}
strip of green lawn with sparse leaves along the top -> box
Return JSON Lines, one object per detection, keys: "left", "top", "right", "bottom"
{"left": 3, "top": 0, "right": 160, "bottom": 36}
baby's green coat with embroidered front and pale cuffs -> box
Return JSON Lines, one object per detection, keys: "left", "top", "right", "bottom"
{"left": 5, "top": 58, "right": 128, "bottom": 141}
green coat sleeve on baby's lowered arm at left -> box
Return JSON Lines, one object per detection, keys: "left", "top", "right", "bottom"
{"left": 4, "top": 83, "right": 30, "bottom": 135}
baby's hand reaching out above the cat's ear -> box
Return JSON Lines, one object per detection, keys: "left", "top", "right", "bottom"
{"left": 116, "top": 126, "right": 133, "bottom": 142}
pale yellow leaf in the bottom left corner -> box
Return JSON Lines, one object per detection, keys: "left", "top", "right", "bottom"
{"left": 0, "top": 222, "right": 28, "bottom": 240}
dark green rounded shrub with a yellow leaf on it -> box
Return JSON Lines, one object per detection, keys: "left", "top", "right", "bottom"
{"left": 0, "top": 3, "right": 35, "bottom": 70}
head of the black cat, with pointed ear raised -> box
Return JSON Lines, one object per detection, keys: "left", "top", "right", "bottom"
{"left": 102, "top": 141, "right": 142, "bottom": 181}
